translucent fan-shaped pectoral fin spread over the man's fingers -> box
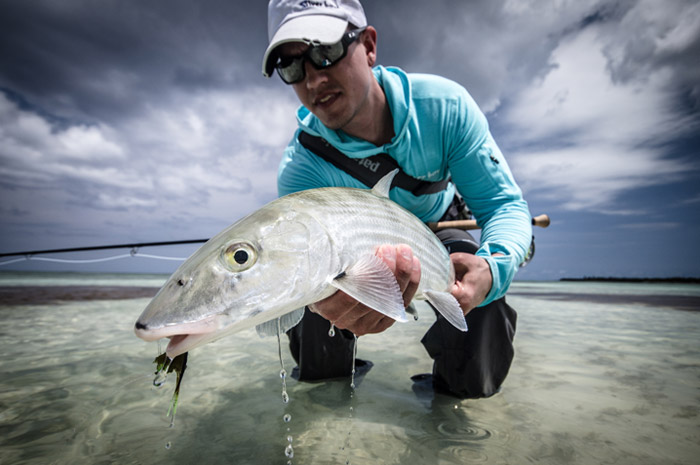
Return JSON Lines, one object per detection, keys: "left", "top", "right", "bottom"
{"left": 330, "top": 255, "right": 407, "bottom": 322}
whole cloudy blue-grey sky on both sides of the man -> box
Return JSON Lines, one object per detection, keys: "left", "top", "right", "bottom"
{"left": 0, "top": 0, "right": 700, "bottom": 279}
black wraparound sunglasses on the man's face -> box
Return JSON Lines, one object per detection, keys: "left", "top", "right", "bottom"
{"left": 275, "top": 28, "right": 365, "bottom": 84}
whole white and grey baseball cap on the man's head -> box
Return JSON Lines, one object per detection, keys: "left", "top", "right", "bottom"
{"left": 262, "top": 0, "right": 367, "bottom": 77}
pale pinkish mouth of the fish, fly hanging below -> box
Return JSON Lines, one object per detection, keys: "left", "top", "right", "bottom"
{"left": 134, "top": 315, "right": 219, "bottom": 358}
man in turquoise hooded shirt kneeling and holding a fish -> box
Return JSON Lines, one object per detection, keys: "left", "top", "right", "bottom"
{"left": 263, "top": 0, "right": 531, "bottom": 397}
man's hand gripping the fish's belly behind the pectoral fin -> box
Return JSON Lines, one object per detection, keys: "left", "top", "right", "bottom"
{"left": 309, "top": 244, "right": 418, "bottom": 336}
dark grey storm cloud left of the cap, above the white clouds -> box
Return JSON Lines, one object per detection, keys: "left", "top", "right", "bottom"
{"left": 0, "top": 0, "right": 266, "bottom": 122}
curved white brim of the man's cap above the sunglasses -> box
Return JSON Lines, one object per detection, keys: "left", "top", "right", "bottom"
{"left": 262, "top": 15, "right": 348, "bottom": 77}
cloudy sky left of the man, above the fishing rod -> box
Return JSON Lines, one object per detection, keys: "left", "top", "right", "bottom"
{"left": 0, "top": 0, "right": 294, "bottom": 254}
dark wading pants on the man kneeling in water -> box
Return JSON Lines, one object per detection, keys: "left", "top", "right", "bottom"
{"left": 287, "top": 229, "right": 517, "bottom": 398}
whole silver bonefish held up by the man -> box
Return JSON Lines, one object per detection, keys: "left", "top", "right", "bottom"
{"left": 135, "top": 171, "right": 467, "bottom": 358}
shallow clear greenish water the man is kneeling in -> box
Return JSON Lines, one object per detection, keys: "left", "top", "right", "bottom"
{"left": 0, "top": 274, "right": 700, "bottom": 464}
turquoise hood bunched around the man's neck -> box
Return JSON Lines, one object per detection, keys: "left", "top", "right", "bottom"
{"left": 297, "top": 66, "right": 415, "bottom": 158}
